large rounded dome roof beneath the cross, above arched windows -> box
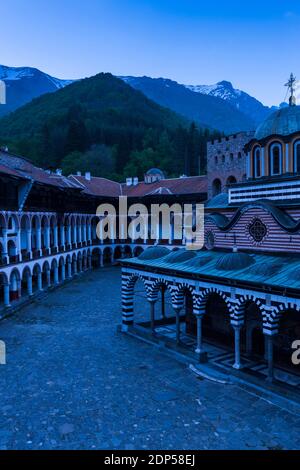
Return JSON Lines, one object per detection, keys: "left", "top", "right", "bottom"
{"left": 254, "top": 106, "right": 300, "bottom": 140}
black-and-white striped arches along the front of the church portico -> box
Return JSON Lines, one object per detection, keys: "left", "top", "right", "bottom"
{"left": 122, "top": 267, "right": 300, "bottom": 335}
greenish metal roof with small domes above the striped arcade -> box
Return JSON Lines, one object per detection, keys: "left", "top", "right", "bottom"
{"left": 123, "top": 249, "right": 300, "bottom": 289}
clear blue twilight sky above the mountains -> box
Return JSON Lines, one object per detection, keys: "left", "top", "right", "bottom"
{"left": 0, "top": 0, "right": 300, "bottom": 105}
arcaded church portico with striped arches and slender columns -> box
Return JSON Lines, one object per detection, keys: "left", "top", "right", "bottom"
{"left": 122, "top": 247, "right": 300, "bottom": 381}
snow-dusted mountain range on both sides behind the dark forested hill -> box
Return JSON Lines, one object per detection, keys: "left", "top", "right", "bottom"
{"left": 0, "top": 65, "right": 282, "bottom": 134}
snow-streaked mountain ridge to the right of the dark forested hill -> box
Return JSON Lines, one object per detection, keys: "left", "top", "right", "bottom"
{"left": 120, "top": 76, "right": 271, "bottom": 134}
